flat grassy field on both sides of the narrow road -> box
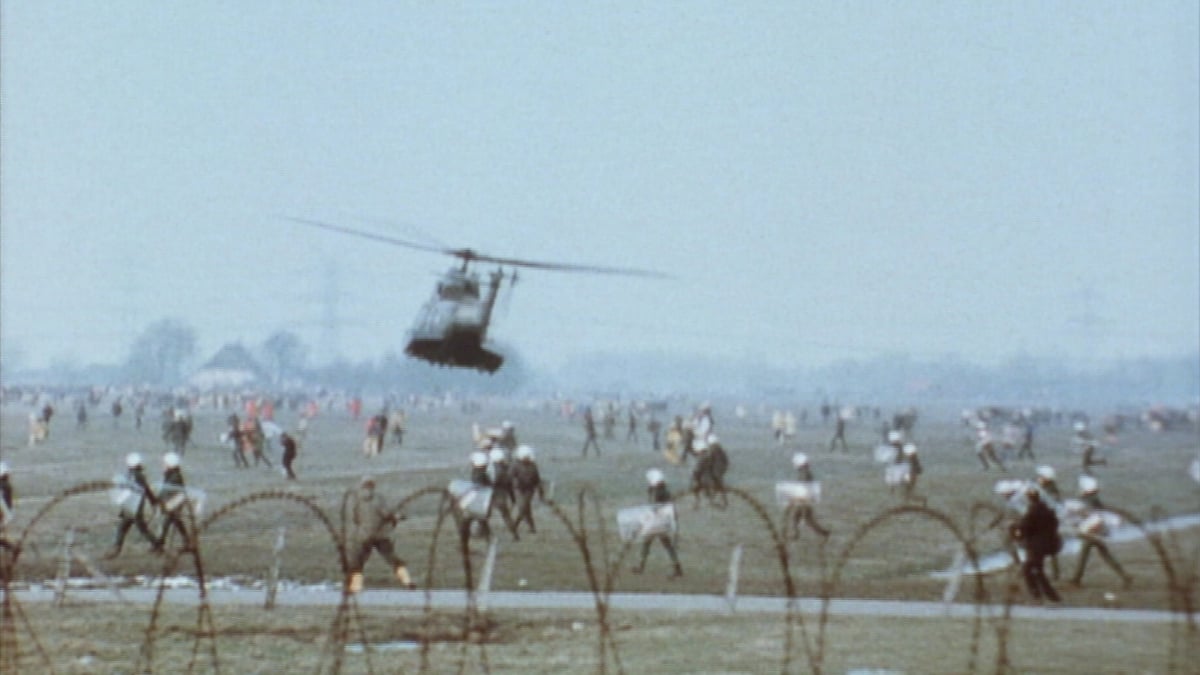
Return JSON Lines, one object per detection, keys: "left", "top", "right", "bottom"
{"left": 0, "top": 401, "right": 1200, "bottom": 673}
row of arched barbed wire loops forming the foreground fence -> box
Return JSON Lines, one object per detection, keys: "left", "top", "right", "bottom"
{"left": 0, "top": 480, "right": 1200, "bottom": 674}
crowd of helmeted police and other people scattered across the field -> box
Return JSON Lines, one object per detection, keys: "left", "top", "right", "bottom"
{"left": 0, "top": 386, "right": 1200, "bottom": 603}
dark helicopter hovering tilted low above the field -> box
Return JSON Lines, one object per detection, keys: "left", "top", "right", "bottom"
{"left": 288, "top": 216, "right": 667, "bottom": 374}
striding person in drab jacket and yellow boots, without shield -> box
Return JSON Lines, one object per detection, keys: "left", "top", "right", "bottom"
{"left": 346, "top": 476, "right": 416, "bottom": 595}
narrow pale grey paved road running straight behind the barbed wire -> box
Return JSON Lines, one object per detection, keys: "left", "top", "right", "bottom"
{"left": 16, "top": 589, "right": 1200, "bottom": 623}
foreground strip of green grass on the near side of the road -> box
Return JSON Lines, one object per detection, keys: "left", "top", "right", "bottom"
{"left": 4, "top": 604, "right": 1200, "bottom": 674}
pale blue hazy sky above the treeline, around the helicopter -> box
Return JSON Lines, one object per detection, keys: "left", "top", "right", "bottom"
{"left": 0, "top": 0, "right": 1200, "bottom": 368}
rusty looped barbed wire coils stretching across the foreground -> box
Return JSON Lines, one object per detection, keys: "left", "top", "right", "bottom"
{"left": 0, "top": 480, "right": 1200, "bottom": 674}
